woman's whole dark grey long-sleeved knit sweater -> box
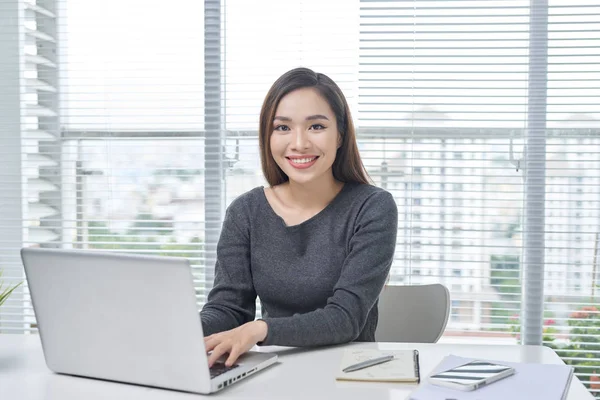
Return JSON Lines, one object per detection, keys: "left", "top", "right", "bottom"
{"left": 200, "top": 183, "right": 398, "bottom": 346}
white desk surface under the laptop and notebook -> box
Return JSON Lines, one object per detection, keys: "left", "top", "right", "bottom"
{"left": 0, "top": 335, "right": 593, "bottom": 400}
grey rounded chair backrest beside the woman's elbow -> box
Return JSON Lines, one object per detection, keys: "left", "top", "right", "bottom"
{"left": 375, "top": 284, "right": 450, "bottom": 343}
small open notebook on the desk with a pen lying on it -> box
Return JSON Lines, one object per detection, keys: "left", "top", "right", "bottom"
{"left": 335, "top": 349, "right": 420, "bottom": 383}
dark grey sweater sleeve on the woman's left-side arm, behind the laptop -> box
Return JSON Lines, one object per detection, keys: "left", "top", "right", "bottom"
{"left": 200, "top": 200, "right": 256, "bottom": 336}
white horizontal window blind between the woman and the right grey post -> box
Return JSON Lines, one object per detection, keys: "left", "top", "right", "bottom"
{"left": 358, "top": 1, "right": 529, "bottom": 342}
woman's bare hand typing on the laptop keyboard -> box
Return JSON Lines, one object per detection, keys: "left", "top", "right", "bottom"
{"left": 204, "top": 321, "right": 268, "bottom": 367}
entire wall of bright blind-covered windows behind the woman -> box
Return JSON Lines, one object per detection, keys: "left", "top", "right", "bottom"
{"left": 0, "top": 0, "right": 600, "bottom": 393}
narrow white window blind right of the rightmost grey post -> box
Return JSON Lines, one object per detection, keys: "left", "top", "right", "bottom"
{"left": 542, "top": 1, "right": 600, "bottom": 397}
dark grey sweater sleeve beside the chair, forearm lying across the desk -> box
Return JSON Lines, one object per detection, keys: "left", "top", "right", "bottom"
{"left": 261, "top": 191, "right": 398, "bottom": 346}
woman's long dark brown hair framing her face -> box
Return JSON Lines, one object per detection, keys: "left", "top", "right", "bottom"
{"left": 259, "top": 68, "right": 370, "bottom": 186}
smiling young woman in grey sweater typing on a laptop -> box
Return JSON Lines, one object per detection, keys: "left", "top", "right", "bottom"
{"left": 200, "top": 68, "right": 398, "bottom": 366}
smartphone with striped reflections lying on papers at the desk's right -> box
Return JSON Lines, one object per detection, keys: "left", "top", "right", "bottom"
{"left": 428, "top": 361, "right": 515, "bottom": 391}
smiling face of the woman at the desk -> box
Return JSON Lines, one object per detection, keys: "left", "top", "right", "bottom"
{"left": 270, "top": 88, "right": 341, "bottom": 184}
